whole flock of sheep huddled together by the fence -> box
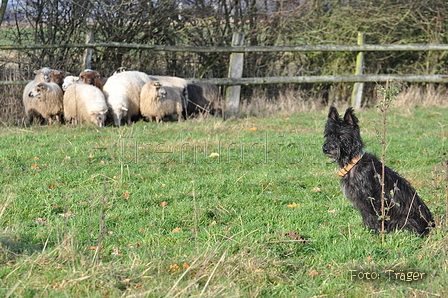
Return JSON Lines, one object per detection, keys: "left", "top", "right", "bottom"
{"left": 23, "top": 67, "right": 222, "bottom": 127}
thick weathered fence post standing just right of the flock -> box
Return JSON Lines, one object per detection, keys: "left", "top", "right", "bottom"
{"left": 224, "top": 32, "right": 244, "bottom": 119}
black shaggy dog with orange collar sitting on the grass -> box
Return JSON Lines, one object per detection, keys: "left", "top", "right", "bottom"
{"left": 322, "top": 107, "right": 434, "bottom": 236}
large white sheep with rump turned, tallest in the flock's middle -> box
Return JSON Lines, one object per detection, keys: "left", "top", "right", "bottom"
{"left": 103, "top": 71, "right": 151, "bottom": 126}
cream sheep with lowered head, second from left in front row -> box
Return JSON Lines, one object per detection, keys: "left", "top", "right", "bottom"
{"left": 63, "top": 84, "right": 108, "bottom": 127}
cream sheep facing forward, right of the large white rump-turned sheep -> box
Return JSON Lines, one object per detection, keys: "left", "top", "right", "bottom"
{"left": 140, "top": 81, "right": 182, "bottom": 123}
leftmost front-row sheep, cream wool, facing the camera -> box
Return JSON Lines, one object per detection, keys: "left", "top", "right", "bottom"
{"left": 24, "top": 82, "right": 63, "bottom": 124}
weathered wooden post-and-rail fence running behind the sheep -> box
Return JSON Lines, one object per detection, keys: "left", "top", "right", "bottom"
{"left": 0, "top": 33, "right": 448, "bottom": 116}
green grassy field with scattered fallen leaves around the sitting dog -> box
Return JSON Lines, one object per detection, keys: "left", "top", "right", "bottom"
{"left": 0, "top": 108, "right": 448, "bottom": 298}
